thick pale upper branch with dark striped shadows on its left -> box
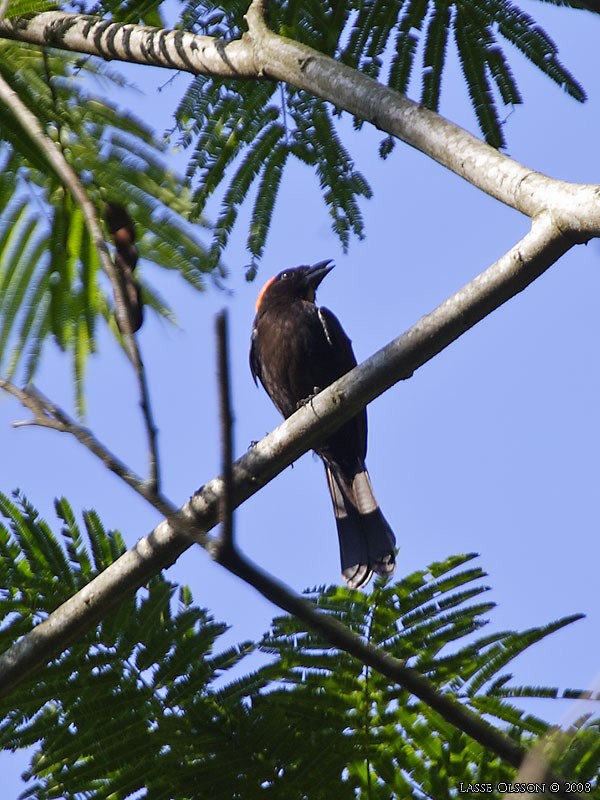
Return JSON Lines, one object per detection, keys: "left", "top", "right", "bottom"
{"left": 0, "top": 8, "right": 600, "bottom": 231}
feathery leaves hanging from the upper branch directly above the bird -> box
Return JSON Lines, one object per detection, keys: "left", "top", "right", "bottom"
{"left": 178, "top": 75, "right": 371, "bottom": 276}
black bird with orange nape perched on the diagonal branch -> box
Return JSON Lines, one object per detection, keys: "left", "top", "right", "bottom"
{"left": 250, "top": 259, "right": 396, "bottom": 589}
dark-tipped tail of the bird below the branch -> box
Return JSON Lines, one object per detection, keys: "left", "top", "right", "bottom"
{"left": 325, "top": 461, "right": 396, "bottom": 589}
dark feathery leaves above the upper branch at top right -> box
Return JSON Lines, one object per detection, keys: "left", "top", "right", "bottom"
{"left": 340, "top": 0, "right": 585, "bottom": 147}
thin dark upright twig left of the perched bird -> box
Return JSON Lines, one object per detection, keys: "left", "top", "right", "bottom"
{"left": 215, "top": 310, "right": 234, "bottom": 556}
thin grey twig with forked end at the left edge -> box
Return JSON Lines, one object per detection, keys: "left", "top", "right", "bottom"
{"left": 0, "top": 378, "right": 176, "bottom": 516}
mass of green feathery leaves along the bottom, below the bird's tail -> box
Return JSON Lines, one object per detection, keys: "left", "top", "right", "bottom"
{"left": 0, "top": 495, "right": 600, "bottom": 800}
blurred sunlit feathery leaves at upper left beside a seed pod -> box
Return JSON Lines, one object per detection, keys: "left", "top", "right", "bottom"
{"left": 0, "top": 41, "right": 211, "bottom": 413}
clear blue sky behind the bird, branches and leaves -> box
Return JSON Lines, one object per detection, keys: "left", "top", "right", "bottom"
{"left": 0, "top": 3, "right": 600, "bottom": 798}
